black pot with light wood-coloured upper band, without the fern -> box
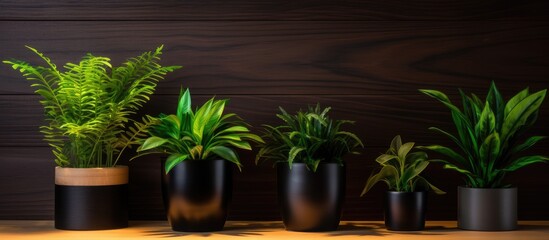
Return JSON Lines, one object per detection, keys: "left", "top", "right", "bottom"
{"left": 55, "top": 166, "right": 128, "bottom": 230}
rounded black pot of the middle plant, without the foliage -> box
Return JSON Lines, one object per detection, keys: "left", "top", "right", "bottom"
{"left": 277, "top": 163, "right": 345, "bottom": 232}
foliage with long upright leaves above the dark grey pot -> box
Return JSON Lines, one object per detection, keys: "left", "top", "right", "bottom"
{"left": 420, "top": 82, "right": 549, "bottom": 188}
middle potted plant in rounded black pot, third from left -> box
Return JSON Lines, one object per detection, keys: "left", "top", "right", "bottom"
{"left": 256, "top": 105, "right": 363, "bottom": 231}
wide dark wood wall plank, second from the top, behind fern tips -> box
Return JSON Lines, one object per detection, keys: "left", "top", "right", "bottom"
{"left": 0, "top": 21, "right": 549, "bottom": 95}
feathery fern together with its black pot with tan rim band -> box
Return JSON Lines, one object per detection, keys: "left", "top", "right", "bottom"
{"left": 3, "top": 46, "right": 179, "bottom": 230}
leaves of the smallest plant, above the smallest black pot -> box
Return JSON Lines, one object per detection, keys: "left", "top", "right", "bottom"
{"left": 360, "top": 135, "right": 445, "bottom": 196}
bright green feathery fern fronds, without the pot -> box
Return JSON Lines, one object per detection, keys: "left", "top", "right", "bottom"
{"left": 3, "top": 46, "right": 180, "bottom": 168}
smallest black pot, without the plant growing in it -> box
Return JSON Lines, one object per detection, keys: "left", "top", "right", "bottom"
{"left": 384, "top": 191, "right": 427, "bottom": 231}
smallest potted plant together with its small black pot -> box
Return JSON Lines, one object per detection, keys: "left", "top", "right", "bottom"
{"left": 360, "top": 135, "right": 444, "bottom": 231}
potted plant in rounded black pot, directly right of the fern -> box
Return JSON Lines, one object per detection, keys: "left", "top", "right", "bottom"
{"left": 137, "top": 89, "right": 263, "bottom": 232}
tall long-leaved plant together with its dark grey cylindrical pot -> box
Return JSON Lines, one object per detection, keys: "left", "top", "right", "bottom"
{"left": 420, "top": 82, "right": 549, "bottom": 230}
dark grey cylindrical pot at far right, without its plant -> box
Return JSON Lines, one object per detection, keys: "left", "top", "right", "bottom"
{"left": 458, "top": 186, "right": 517, "bottom": 231}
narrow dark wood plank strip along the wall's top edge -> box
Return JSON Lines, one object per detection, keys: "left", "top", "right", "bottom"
{"left": 0, "top": 0, "right": 549, "bottom": 21}
